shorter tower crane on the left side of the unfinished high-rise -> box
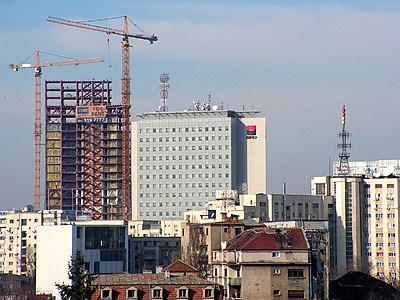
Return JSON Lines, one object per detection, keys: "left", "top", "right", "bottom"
{"left": 10, "top": 51, "right": 104, "bottom": 210}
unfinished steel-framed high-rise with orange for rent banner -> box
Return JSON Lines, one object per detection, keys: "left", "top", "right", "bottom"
{"left": 45, "top": 81, "right": 129, "bottom": 220}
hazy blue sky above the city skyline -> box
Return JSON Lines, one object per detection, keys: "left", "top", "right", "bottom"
{"left": 0, "top": 0, "right": 400, "bottom": 210}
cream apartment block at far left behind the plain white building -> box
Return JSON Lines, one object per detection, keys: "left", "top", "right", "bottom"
{"left": 0, "top": 207, "right": 90, "bottom": 276}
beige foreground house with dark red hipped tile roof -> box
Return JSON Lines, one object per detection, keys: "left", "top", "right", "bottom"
{"left": 209, "top": 228, "right": 311, "bottom": 299}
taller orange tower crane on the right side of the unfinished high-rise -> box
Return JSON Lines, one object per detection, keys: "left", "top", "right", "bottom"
{"left": 47, "top": 16, "right": 158, "bottom": 220}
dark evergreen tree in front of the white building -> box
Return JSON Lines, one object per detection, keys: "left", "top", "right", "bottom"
{"left": 56, "top": 252, "right": 95, "bottom": 300}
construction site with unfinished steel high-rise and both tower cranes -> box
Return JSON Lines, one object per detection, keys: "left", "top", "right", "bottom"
{"left": 10, "top": 16, "right": 157, "bottom": 220}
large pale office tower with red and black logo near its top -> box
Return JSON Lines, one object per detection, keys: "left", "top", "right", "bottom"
{"left": 132, "top": 109, "right": 266, "bottom": 219}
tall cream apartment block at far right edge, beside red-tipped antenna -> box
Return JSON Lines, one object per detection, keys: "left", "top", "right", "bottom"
{"left": 311, "top": 160, "right": 400, "bottom": 281}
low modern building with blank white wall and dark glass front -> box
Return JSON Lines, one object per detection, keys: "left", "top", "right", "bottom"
{"left": 36, "top": 220, "right": 128, "bottom": 299}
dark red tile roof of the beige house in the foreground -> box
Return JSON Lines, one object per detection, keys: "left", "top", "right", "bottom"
{"left": 226, "top": 228, "right": 308, "bottom": 251}
